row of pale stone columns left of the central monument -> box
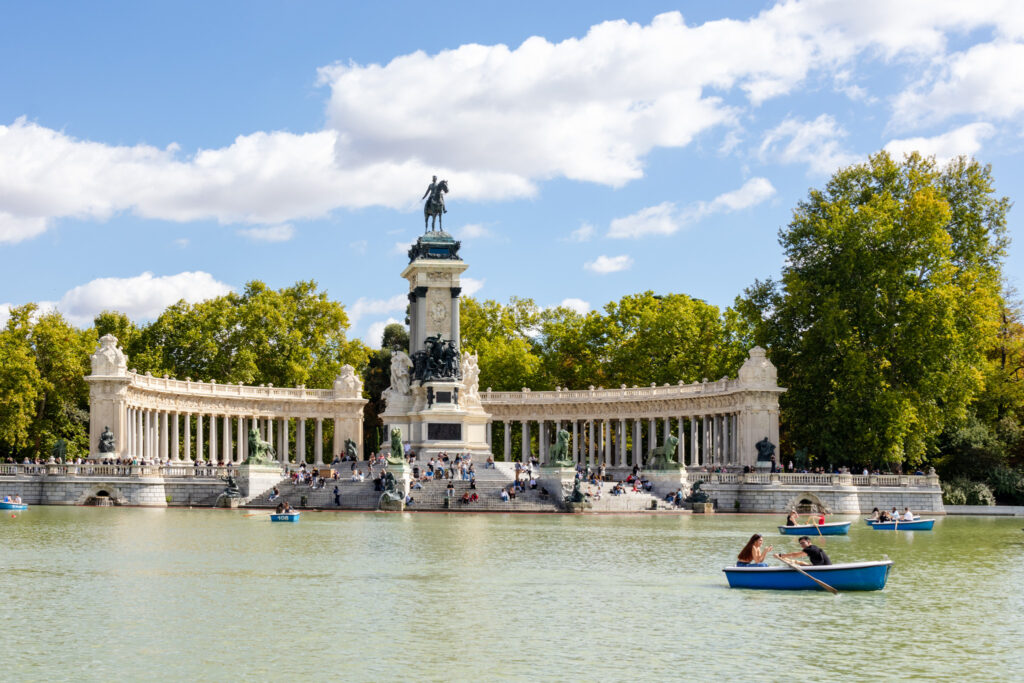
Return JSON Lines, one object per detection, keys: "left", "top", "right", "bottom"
{"left": 126, "top": 405, "right": 337, "bottom": 465}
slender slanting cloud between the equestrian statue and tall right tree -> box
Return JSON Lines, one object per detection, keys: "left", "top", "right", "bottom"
{"left": 608, "top": 178, "right": 775, "bottom": 239}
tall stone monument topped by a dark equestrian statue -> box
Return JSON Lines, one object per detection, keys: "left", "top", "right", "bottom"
{"left": 381, "top": 177, "right": 490, "bottom": 459}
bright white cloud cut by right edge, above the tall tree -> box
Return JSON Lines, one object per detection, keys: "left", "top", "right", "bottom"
{"left": 893, "top": 41, "right": 1024, "bottom": 125}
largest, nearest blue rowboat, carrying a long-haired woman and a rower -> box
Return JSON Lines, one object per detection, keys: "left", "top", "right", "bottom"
{"left": 722, "top": 560, "right": 893, "bottom": 591}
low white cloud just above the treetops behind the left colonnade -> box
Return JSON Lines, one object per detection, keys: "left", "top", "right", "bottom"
{"left": 56, "top": 270, "right": 231, "bottom": 326}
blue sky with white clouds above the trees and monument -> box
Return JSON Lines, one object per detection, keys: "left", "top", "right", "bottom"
{"left": 0, "top": 0, "right": 1024, "bottom": 347}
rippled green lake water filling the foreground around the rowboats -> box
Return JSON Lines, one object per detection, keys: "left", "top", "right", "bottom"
{"left": 0, "top": 507, "right": 1024, "bottom": 681}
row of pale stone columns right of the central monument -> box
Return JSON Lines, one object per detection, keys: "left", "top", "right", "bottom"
{"left": 487, "top": 413, "right": 740, "bottom": 467}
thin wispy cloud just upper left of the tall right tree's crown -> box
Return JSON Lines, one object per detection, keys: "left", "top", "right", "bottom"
{"left": 759, "top": 114, "right": 859, "bottom": 175}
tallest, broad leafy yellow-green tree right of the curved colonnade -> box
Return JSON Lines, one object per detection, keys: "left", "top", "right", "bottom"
{"left": 736, "top": 153, "right": 1010, "bottom": 465}
